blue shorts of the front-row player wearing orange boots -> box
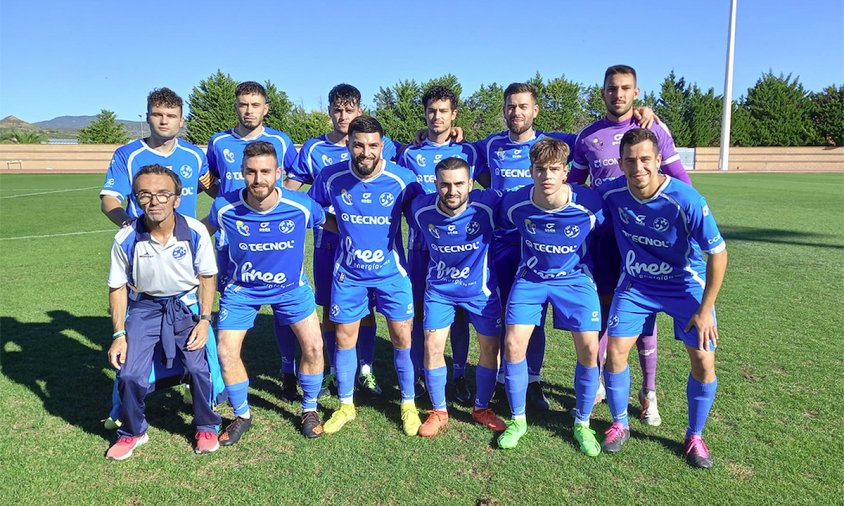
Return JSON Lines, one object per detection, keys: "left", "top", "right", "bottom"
{"left": 422, "top": 290, "right": 502, "bottom": 336}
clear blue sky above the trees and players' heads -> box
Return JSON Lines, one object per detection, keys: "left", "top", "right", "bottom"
{"left": 0, "top": 0, "right": 844, "bottom": 122}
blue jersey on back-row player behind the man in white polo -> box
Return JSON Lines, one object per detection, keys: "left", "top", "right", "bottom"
{"left": 100, "top": 138, "right": 212, "bottom": 218}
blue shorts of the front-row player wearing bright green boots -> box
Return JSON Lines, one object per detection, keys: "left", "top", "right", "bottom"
{"left": 507, "top": 276, "right": 601, "bottom": 332}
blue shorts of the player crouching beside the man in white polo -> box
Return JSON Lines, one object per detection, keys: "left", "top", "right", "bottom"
{"left": 217, "top": 285, "right": 316, "bottom": 330}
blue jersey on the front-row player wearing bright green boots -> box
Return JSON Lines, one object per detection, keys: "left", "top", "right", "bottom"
{"left": 499, "top": 185, "right": 604, "bottom": 281}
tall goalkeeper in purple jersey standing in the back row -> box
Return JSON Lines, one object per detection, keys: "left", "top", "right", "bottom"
{"left": 569, "top": 65, "right": 691, "bottom": 426}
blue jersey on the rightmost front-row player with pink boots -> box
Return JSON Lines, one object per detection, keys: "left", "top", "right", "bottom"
{"left": 598, "top": 176, "right": 726, "bottom": 287}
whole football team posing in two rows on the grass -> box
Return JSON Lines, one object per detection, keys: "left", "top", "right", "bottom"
{"left": 101, "top": 65, "right": 726, "bottom": 467}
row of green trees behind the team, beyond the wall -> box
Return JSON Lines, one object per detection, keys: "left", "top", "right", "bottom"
{"left": 74, "top": 70, "right": 844, "bottom": 147}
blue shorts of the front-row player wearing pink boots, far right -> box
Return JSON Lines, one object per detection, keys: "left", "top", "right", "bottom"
{"left": 607, "top": 276, "right": 717, "bottom": 350}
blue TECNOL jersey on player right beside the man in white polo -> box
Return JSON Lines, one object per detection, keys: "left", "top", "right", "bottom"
{"left": 209, "top": 188, "right": 325, "bottom": 297}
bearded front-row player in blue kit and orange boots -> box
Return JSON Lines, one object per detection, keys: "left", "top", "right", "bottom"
{"left": 410, "top": 157, "right": 506, "bottom": 437}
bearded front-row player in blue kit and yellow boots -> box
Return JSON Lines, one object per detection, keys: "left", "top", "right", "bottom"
{"left": 310, "top": 116, "right": 421, "bottom": 435}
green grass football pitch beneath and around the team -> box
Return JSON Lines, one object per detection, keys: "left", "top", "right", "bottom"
{"left": 0, "top": 174, "right": 844, "bottom": 504}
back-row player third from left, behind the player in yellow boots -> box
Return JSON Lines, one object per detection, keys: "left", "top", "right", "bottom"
{"left": 284, "top": 83, "right": 398, "bottom": 398}
